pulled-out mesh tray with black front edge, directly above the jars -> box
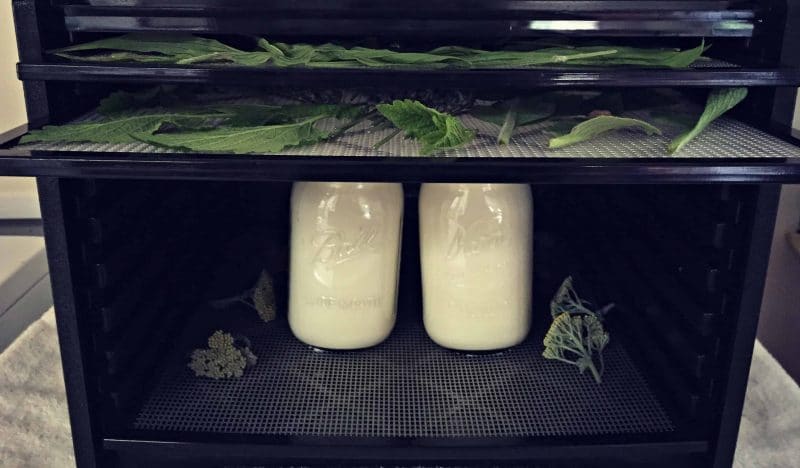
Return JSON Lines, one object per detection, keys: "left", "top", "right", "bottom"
{"left": 0, "top": 107, "right": 800, "bottom": 183}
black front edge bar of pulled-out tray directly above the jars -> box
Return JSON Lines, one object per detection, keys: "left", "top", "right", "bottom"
{"left": 0, "top": 154, "right": 800, "bottom": 184}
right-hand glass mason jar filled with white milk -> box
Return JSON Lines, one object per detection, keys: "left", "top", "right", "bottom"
{"left": 419, "top": 184, "right": 533, "bottom": 351}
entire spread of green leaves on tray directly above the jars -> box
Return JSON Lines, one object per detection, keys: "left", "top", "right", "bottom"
{"left": 21, "top": 86, "right": 747, "bottom": 155}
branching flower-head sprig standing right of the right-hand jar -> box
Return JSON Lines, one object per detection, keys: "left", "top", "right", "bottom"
{"left": 542, "top": 276, "right": 614, "bottom": 383}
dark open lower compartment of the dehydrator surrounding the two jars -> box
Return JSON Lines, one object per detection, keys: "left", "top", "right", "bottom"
{"left": 64, "top": 180, "right": 751, "bottom": 444}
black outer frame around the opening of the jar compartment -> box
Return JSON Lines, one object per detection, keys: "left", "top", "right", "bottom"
{"left": 32, "top": 177, "right": 780, "bottom": 468}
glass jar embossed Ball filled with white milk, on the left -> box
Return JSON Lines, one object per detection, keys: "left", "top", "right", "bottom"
{"left": 289, "top": 182, "right": 403, "bottom": 349}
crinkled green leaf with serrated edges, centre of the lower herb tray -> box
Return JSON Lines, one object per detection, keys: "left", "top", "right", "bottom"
{"left": 377, "top": 99, "right": 475, "bottom": 155}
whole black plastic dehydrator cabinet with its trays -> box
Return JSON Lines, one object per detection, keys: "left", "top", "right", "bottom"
{"left": 0, "top": 0, "right": 800, "bottom": 468}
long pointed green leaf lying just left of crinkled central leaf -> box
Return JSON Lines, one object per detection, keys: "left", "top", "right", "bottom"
{"left": 134, "top": 115, "right": 327, "bottom": 154}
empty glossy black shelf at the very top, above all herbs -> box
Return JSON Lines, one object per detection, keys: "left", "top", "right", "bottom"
{"left": 58, "top": 0, "right": 755, "bottom": 39}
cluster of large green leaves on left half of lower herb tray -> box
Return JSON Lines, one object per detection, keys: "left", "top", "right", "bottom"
{"left": 21, "top": 86, "right": 364, "bottom": 154}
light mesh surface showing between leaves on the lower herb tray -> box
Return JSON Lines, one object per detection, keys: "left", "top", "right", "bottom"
{"left": 19, "top": 103, "right": 800, "bottom": 158}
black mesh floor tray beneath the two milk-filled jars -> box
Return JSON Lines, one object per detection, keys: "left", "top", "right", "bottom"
{"left": 134, "top": 319, "right": 674, "bottom": 437}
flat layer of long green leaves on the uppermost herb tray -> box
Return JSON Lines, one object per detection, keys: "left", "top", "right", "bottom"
{"left": 52, "top": 34, "right": 706, "bottom": 69}
